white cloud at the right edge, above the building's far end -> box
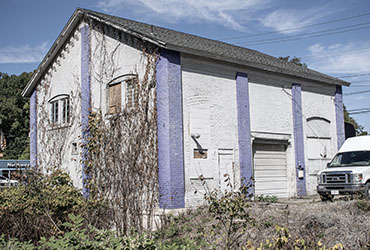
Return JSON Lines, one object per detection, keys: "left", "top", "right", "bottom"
{"left": 308, "top": 41, "right": 370, "bottom": 74}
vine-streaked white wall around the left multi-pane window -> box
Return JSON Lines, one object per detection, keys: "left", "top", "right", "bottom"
{"left": 37, "top": 32, "right": 81, "bottom": 171}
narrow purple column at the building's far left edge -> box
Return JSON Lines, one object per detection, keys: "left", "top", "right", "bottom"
{"left": 30, "top": 88, "right": 37, "bottom": 168}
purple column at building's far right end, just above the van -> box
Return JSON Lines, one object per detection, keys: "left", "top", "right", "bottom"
{"left": 334, "top": 85, "right": 345, "bottom": 150}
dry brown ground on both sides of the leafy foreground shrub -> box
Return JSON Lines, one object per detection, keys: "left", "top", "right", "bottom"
{"left": 159, "top": 197, "right": 370, "bottom": 249}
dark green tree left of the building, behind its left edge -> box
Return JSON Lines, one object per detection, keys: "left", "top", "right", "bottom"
{"left": 0, "top": 72, "right": 32, "bottom": 159}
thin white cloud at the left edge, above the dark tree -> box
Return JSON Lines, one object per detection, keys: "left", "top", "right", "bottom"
{"left": 0, "top": 42, "right": 48, "bottom": 64}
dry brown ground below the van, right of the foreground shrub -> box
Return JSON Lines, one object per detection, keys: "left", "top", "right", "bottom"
{"left": 246, "top": 200, "right": 370, "bottom": 249}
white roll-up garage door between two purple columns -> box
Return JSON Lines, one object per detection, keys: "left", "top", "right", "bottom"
{"left": 253, "top": 144, "right": 288, "bottom": 197}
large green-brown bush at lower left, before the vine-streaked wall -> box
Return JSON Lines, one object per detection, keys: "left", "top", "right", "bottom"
{"left": 0, "top": 170, "right": 109, "bottom": 241}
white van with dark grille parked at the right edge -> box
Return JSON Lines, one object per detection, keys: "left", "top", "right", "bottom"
{"left": 317, "top": 135, "right": 370, "bottom": 200}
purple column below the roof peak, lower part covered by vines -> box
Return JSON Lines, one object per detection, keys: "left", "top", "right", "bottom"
{"left": 81, "top": 25, "right": 91, "bottom": 198}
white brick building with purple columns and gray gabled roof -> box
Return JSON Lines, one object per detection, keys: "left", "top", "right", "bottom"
{"left": 23, "top": 9, "right": 349, "bottom": 208}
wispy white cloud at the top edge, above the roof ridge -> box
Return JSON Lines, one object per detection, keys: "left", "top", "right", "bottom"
{"left": 98, "top": 0, "right": 270, "bottom": 30}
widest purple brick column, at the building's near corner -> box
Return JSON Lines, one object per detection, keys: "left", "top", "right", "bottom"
{"left": 156, "top": 49, "right": 185, "bottom": 209}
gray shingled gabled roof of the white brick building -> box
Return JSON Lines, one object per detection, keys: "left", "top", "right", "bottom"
{"left": 22, "top": 8, "right": 350, "bottom": 96}
